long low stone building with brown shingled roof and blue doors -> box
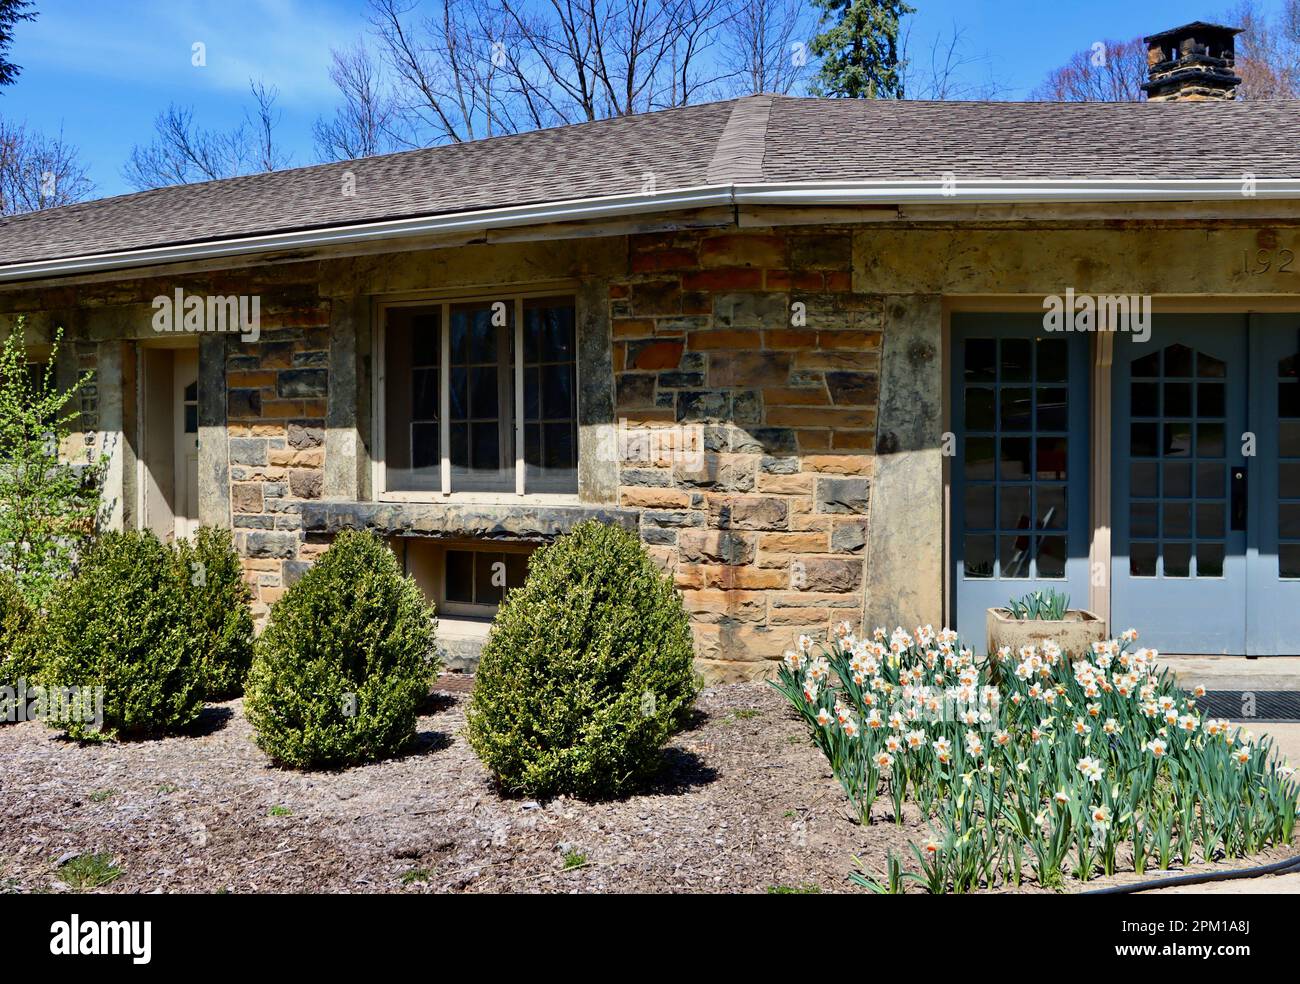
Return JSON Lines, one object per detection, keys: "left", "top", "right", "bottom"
{"left": 0, "top": 25, "right": 1300, "bottom": 680}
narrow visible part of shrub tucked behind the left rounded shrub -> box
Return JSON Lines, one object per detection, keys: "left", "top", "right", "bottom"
{"left": 177, "top": 526, "right": 252, "bottom": 701}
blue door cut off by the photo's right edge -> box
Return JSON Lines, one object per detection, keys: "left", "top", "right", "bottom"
{"left": 1244, "top": 315, "right": 1300, "bottom": 656}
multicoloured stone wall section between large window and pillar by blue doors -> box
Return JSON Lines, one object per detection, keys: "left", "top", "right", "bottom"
{"left": 610, "top": 230, "right": 884, "bottom": 680}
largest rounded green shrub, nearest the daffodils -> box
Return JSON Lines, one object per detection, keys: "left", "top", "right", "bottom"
{"left": 468, "top": 523, "right": 698, "bottom": 797}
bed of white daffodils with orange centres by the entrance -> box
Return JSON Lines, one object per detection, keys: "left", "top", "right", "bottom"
{"left": 774, "top": 624, "right": 1300, "bottom": 893}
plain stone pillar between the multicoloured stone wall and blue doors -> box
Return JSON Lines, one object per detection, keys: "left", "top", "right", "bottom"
{"left": 866, "top": 295, "right": 945, "bottom": 630}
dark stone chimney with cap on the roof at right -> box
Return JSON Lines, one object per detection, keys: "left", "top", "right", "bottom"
{"left": 1143, "top": 21, "right": 1242, "bottom": 103}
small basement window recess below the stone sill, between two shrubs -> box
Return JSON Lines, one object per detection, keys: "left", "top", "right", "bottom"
{"left": 397, "top": 537, "right": 536, "bottom": 619}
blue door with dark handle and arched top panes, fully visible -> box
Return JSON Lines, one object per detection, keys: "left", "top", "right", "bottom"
{"left": 1110, "top": 315, "right": 1249, "bottom": 655}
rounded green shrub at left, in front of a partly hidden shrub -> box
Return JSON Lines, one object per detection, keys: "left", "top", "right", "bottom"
{"left": 39, "top": 530, "right": 203, "bottom": 738}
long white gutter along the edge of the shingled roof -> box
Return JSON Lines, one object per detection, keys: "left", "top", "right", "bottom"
{"left": 0, "top": 175, "right": 1300, "bottom": 282}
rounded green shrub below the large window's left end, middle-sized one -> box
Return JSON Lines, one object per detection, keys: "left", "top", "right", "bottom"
{"left": 246, "top": 530, "right": 438, "bottom": 768}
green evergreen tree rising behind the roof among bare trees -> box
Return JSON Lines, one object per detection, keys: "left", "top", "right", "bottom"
{"left": 809, "top": 0, "right": 915, "bottom": 99}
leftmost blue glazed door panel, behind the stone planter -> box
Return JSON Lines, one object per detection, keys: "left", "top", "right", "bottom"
{"left": 950, "top": 315, "right": 1091, "bottom": 651}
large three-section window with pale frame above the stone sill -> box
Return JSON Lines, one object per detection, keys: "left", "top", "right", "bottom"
{"left": 376, "top": 292, "right": 577, "bottom": 498}
